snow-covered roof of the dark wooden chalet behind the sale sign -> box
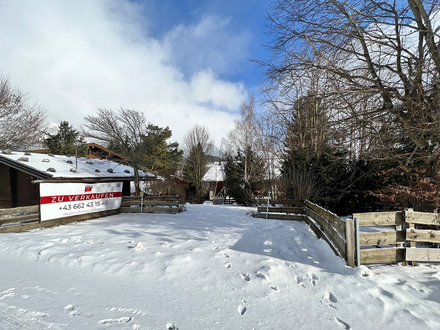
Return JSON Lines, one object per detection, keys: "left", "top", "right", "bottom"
{"left": 0, "top": 151, "right": 155, "bottom": 179}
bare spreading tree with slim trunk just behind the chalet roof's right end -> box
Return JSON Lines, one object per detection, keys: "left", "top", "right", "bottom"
{"left": 82, "top": 108, "right": 148, "bottom": 195}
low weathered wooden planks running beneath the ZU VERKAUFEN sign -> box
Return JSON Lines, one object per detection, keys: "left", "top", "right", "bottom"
{"left": 0, "top": 210, "right": 120, "bottom": 233}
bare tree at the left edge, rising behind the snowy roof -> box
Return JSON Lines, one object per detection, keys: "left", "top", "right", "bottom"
{"left": 0, "top": 75, "right": 46, "bottom": 149}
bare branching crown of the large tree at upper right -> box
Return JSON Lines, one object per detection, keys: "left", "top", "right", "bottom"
{"left": 264, "top": 0, "right": 440, "bottom": 168}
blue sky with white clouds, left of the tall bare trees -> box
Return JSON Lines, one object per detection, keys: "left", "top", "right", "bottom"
{"left": 0, "top": 0, "right": 271, "bottom": 145}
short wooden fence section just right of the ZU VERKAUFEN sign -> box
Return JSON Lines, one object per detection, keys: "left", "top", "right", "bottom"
{"left": 121, "top": 196, "right": 181, "bottom": 213}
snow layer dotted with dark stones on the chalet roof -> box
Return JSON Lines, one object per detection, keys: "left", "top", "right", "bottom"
{"left": 0, "top": 151, "right": 154, "bottom": 178}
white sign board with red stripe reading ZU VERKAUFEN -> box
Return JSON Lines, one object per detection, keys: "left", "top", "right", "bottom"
{"left": 40, "top": 182, "right": 122, "bottom": 221}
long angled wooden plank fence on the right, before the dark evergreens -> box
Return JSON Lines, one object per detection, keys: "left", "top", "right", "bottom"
{"left": 255, "top": 200, "right": 440, "bottom": 267}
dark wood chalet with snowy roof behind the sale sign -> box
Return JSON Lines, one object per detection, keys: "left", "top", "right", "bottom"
{"left": 0, "top": 151, "right": 155, "bottom": 208}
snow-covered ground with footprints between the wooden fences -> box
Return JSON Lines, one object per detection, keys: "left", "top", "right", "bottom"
{"left": 0, "top": 205, "right": 440, "bottom": 330}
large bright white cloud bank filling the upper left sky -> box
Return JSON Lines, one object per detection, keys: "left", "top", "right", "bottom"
{"left": 0, "top": 0, "right": 246, "bottom": 144}
